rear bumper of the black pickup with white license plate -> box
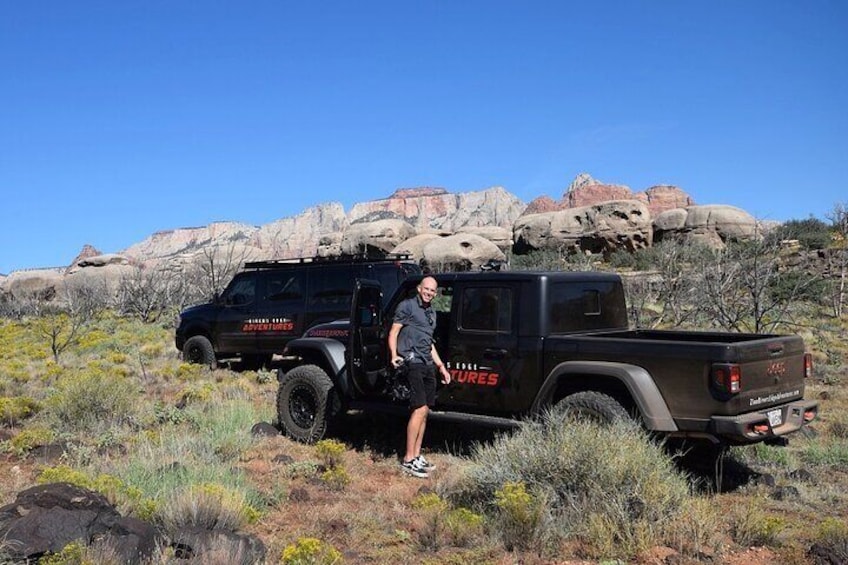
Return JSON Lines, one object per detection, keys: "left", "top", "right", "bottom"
{"left": 709, "top": 400, "right": 819, "bottom": 444}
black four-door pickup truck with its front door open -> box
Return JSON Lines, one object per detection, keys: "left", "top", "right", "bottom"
{"left": 277, "top": 272, "right": 818, "bottom": 446}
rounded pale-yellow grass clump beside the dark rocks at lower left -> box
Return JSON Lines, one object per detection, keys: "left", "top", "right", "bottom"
{"left": 156, "top": 483, "right": 261, "bottom": 531}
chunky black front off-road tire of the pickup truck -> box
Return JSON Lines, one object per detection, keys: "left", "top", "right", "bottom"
{"left": 277, "top": 365, "right": 335, "bottom": 443}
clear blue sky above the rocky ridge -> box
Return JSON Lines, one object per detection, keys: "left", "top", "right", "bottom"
{"left": 0, "top": 0, "right": 848, "bottom": 273}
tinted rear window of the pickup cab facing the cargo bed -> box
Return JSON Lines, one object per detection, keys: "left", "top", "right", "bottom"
{"left": 549, "top": 283, "right": 626, "bottom": 333}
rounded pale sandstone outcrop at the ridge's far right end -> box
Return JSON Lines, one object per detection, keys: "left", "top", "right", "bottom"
{"left": 654, "top": 204, "right": 758, "bottom": 247}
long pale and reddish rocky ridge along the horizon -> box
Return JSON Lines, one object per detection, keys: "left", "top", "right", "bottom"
{"left": 0, "top": 173, "right": 756, "bottom": 302}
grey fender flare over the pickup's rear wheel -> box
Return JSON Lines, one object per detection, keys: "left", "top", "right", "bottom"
{"left": 531, "top": 361, "right": 678, "bottom": 432}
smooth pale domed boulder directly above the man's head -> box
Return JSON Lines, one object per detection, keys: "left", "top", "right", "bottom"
{"left": 421, "top": 233, "right": 506, "bottom": 271}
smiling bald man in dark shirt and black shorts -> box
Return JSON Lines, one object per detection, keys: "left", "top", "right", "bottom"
{"left": 389, "top": 277, "right": 450, "bottom": 478}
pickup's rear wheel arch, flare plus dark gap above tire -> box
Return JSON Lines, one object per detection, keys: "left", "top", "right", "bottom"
{"left": 531, "top": 361, "right": 678, "bottom": 432}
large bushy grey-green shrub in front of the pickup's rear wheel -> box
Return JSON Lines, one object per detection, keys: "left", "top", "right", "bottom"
{"left": 448, "top": 412, "right": 704, "bottom": 558}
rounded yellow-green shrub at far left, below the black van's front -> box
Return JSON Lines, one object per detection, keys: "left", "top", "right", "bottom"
{"left": 44, "top": 369, "right": 139, "bottom": 432}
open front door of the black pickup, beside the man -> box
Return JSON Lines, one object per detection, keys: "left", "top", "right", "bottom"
{"left": 346, "top": 279, "right": 388, "bottom": 397}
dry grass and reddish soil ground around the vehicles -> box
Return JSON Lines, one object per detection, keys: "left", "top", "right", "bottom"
{"left": 0, "top": 310, "right": 848, "bottom": 564}
